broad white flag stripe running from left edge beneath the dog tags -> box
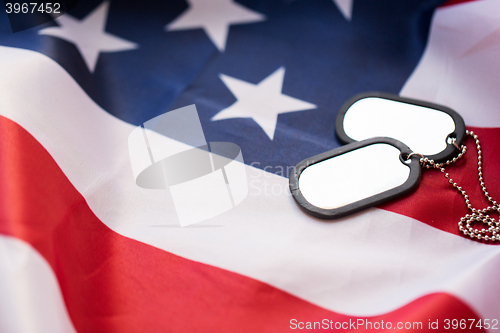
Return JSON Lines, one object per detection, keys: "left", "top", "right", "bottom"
{"left": 0, "top": 47, "right": 500, "bottom": 318}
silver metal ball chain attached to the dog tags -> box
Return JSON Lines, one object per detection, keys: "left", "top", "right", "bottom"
{"left": 416, "top": 131, "right": 500, "bottom": 242}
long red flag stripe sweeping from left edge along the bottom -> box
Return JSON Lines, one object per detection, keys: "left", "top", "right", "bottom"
{"left": 0, "top": 117, "right": 484, "bottom": 332}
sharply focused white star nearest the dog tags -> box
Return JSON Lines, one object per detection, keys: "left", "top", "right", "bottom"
{"left": 212, "top": 67, "right": 316, "bottom": 140}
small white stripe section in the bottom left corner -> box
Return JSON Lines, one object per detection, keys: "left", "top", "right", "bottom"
{"left": 0, "top": 235, "right": 76, "bottom": 333}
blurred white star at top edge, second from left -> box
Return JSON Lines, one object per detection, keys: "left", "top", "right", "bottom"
{"left": 165, "top": 0, "right": 266, "bottom": 52}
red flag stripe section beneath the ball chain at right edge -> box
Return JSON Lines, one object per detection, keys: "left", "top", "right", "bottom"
{"left": 380, "top": 127, "right": 500, "bottom": 245}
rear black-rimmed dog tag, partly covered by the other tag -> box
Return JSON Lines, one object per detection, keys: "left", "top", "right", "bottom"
{"left": 335, "top": 92, "right": 465, "bottom": 162}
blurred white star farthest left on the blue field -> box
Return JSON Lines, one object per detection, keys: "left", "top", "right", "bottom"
{"left": 38, "top": 1, "right": 138, "bottom": 72}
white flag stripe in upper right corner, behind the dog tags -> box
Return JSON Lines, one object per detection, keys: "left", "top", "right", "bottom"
{"left": 400, "top": 0, "right": 500, "bottom": 127}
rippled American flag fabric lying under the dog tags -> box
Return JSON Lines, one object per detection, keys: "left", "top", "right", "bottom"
{"left": 0, "top": 0, "right": 500, "bottom": 332}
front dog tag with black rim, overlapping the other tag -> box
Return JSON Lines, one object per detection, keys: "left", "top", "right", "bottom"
{"left": 289, "top": 137, "right": 420, "bottom": 219}
